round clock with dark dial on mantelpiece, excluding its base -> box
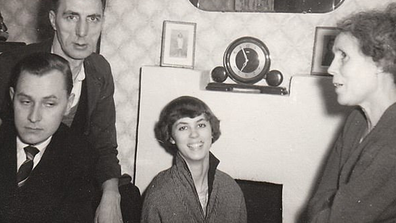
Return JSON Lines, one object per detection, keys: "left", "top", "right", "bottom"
{"left": 223, "top": 36, "right": 271, "bottom": 84}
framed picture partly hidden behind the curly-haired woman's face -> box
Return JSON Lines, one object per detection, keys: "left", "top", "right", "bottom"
{"left": 311, "top": 27, "right": 338, "bottom": 75}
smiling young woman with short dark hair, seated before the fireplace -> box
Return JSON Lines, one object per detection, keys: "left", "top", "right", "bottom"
{"left": 141, "top": 96, "right": 247, "bottom": 223}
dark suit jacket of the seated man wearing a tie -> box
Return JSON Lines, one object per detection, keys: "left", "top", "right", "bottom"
{"left": 0, "top": 123, "right": 96, "bottom": 223}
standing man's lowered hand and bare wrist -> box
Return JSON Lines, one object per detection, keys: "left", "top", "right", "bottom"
{"left": 95, "top": 178, "right": 122, "bottom": 223}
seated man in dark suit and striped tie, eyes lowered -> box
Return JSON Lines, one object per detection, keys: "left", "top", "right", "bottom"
{"left": 0, "top": 53, "right": 96, "bottom": 223}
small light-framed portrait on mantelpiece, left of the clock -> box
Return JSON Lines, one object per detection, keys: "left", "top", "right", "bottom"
{"left": 160, "top": 20, "right": 197, "bottom": 69}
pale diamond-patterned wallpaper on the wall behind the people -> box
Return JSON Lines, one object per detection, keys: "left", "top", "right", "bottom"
{"left": 0, "top": 0, "right": 396, "bottom": 178}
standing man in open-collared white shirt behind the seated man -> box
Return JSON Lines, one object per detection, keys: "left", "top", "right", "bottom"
{"left": 0, "top": 0, "right": 122, "bottom": 223}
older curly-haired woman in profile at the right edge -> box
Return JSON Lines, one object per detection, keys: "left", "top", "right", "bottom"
{"left": 308, "top": 4, "right": 396, "bottom": 223}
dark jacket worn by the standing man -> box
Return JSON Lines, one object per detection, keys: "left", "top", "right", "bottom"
{"left": 0, "top": 39, "right": 121, "bottom": 185}
